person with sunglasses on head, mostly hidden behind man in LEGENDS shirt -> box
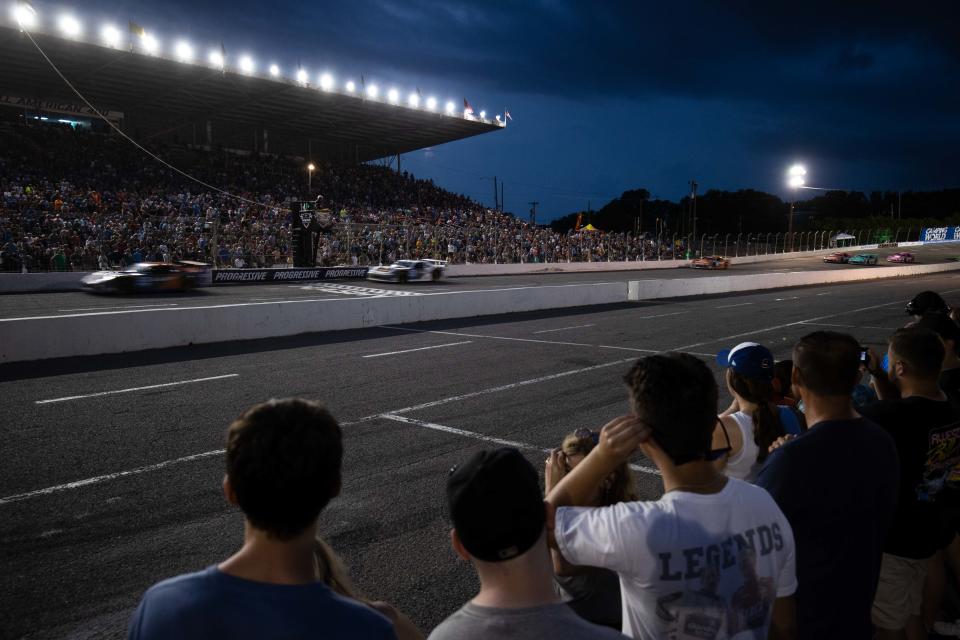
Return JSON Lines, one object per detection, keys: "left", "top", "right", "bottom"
{"left": 544, "top": 428, "right": 639, "bottom": 629}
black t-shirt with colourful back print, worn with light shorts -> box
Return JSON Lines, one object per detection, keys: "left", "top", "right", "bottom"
{"left": 859, "top": 397, "right": 960, "bottom": 559}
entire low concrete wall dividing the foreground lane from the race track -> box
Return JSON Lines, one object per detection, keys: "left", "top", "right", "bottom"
{"left": 0, "top": 263, "right": 960, "bottom": 363}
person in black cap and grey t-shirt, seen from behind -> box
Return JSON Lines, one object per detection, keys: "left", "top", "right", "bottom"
{"left": 430, "top": 447, "right": 623, "bottom": 640}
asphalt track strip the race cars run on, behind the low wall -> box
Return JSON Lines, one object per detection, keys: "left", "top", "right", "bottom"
{"left": 0, "top": 244, "right": 960, "bottom": 318}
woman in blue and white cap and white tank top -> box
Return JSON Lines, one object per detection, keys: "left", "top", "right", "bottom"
{"left": 713, "top": 342, "right": 800, "bottom": 482}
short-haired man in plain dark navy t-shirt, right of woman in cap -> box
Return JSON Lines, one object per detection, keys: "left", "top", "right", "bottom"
{"left": 757, "top": 331, "right": 899, "bottom": 640}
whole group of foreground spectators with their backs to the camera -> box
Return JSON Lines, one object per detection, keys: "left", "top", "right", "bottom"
{"left": 122, "top": 291, "right": 960, "bottom": 640}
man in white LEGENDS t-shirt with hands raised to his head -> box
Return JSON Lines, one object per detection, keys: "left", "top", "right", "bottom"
{"left": 547, "top": 353, "right": 797, "bottom": 640}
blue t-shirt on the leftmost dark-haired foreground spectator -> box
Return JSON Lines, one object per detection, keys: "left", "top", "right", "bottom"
{"left": 127, "top": 566, "right": 396, "bottom": 640}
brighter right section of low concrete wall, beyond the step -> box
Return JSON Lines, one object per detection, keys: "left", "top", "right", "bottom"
{"left": 627, "top": 262, "right": 960, "bottom": 302}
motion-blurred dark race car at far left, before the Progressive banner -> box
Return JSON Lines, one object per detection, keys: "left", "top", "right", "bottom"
{"left": 80, "top": 260, "right": 210, "bottom": 293}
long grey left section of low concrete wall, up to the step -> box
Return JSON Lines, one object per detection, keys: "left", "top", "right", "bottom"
{"left": 0, "top": 282, "right": 627, "bottom": 362}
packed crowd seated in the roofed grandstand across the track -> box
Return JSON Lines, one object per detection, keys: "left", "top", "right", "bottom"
{"left": 0, "top": 123, "right": 688, "bottom": 271}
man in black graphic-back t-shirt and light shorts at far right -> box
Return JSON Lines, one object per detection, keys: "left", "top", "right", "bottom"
{"left": 860, "top": 330, "right": 960, "bottom": 640}
